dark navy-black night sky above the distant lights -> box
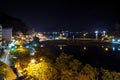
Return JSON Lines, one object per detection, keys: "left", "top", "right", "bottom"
{"left": 0, "top": 0, "right": 120, "bottom": 31}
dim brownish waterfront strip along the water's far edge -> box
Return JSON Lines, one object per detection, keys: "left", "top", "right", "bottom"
{"left": 40, "top": 38, "right": 111, "bottom": 45}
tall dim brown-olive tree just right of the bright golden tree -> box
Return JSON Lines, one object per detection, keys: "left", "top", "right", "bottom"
{"left": 56, "top": 53, "right": 75, "bottom": 80}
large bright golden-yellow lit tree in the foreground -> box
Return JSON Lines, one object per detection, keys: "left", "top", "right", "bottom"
{"left": 23, "top": 61, "right": 57, "bottom": 80}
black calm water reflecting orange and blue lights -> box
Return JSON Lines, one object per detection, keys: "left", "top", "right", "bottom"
{"left": 42, "top": 44, "right": 120, "bottom": 71}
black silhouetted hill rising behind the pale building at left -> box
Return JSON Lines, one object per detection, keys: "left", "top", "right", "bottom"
{"left": 0, "top": 12, "right": 28, "bottom": 35}
